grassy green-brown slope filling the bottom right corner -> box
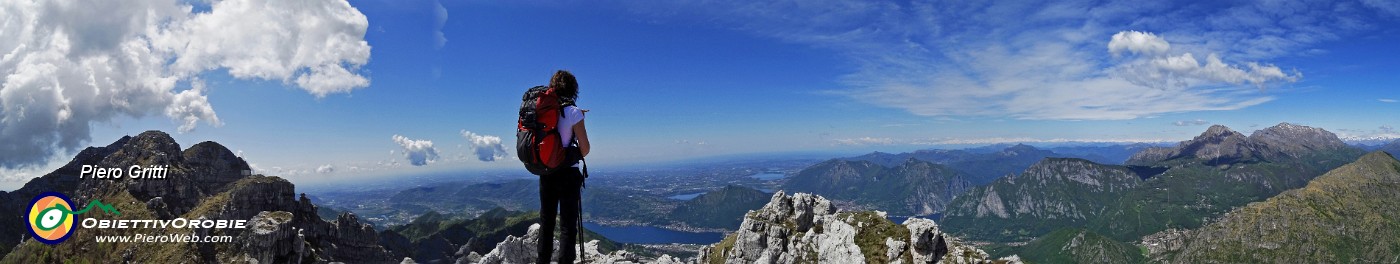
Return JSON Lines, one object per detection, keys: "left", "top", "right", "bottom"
{"left": 1148, "top": 151, "right": 1400, "bottom": 263}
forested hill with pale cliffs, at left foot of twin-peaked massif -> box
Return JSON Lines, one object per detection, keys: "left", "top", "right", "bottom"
{"left": 942, "top": 158, "right": 1142, "bottom": 240}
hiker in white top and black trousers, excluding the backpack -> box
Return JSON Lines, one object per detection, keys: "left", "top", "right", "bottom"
{"left": 536, "top": 70, "right": 588, "bottom": 263}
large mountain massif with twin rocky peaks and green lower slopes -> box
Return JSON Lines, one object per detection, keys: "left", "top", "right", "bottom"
{"left": 942, "top": 123, "right": 1362, "bottom": 240}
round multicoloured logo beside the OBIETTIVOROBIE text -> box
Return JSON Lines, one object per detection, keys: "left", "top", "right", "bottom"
{"left": 25, "top": 191, "right": 73, "bottom": 244}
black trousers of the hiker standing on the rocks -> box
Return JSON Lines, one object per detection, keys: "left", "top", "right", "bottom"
{"left": 536, "top": 168, "right": 584, "bottom": 263}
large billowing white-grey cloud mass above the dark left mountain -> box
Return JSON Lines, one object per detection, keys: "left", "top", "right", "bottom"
{"left": 0, "top": 0, "right": 370, "bottom": 169}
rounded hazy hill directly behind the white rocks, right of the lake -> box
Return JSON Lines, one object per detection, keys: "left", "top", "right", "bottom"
{"left": 783, "top": 159, "right": 970, "bottom": 215}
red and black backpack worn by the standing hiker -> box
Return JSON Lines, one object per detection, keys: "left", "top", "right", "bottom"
{"left": 515, "top": 87, "right": 573, "bottom": 175}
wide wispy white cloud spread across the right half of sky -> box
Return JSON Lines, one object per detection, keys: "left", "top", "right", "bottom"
{"left": 627, "top": 0, "right": 1379, "bottom": 120}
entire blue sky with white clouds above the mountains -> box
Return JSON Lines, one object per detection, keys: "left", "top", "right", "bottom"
{"left": 0, "top": 0, "right": 1400, "bottom": 189}
